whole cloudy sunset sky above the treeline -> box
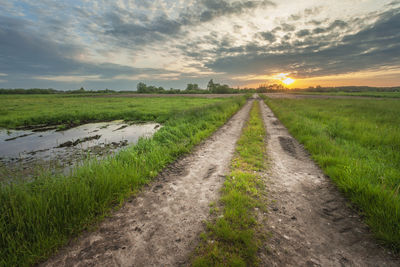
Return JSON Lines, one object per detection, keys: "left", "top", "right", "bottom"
{"left": 0, "top": 0, "right": 400, "bottom": 90}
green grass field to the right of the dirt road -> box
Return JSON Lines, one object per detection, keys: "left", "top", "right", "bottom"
{"left": 266, "top": 99, "right": 400, "bottom": 251}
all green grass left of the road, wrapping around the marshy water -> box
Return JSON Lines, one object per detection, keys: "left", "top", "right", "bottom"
{"left": 0, "top": 93, "right": 245, "bottom": 266}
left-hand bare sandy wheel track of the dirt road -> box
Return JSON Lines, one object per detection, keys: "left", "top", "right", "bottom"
{"left": 42, "top": 101, "right": 252, "bottom": 266}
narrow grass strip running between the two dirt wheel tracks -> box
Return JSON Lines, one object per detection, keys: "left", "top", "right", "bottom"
{"left": 193, "top": 102, "right": 265, "bottom": 266}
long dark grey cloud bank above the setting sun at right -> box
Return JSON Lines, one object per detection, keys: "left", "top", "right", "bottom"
{"left": 207, "top": 9, "right": 400, "bottom": 77}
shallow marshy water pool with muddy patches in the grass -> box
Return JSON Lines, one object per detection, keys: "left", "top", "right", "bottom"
{"left": 0, "top": 121, "right": 160, "bottom": 180}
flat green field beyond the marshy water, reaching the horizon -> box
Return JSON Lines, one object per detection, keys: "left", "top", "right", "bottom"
{"left": 0, "top": 95, "right": 229, "bottom": 128}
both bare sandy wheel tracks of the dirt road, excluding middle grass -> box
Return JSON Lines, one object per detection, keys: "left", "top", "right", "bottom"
{"left": 42, "top": 101, "right": 400, "bottom": 266}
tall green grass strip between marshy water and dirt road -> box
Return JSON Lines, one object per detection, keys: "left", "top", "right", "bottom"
{"left": 0, "top": 97, "right": 245, "bottom": 266}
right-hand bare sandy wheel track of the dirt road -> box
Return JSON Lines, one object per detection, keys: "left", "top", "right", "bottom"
{"left": 260, "top": 103, "right": 400, "bottom": 266}
